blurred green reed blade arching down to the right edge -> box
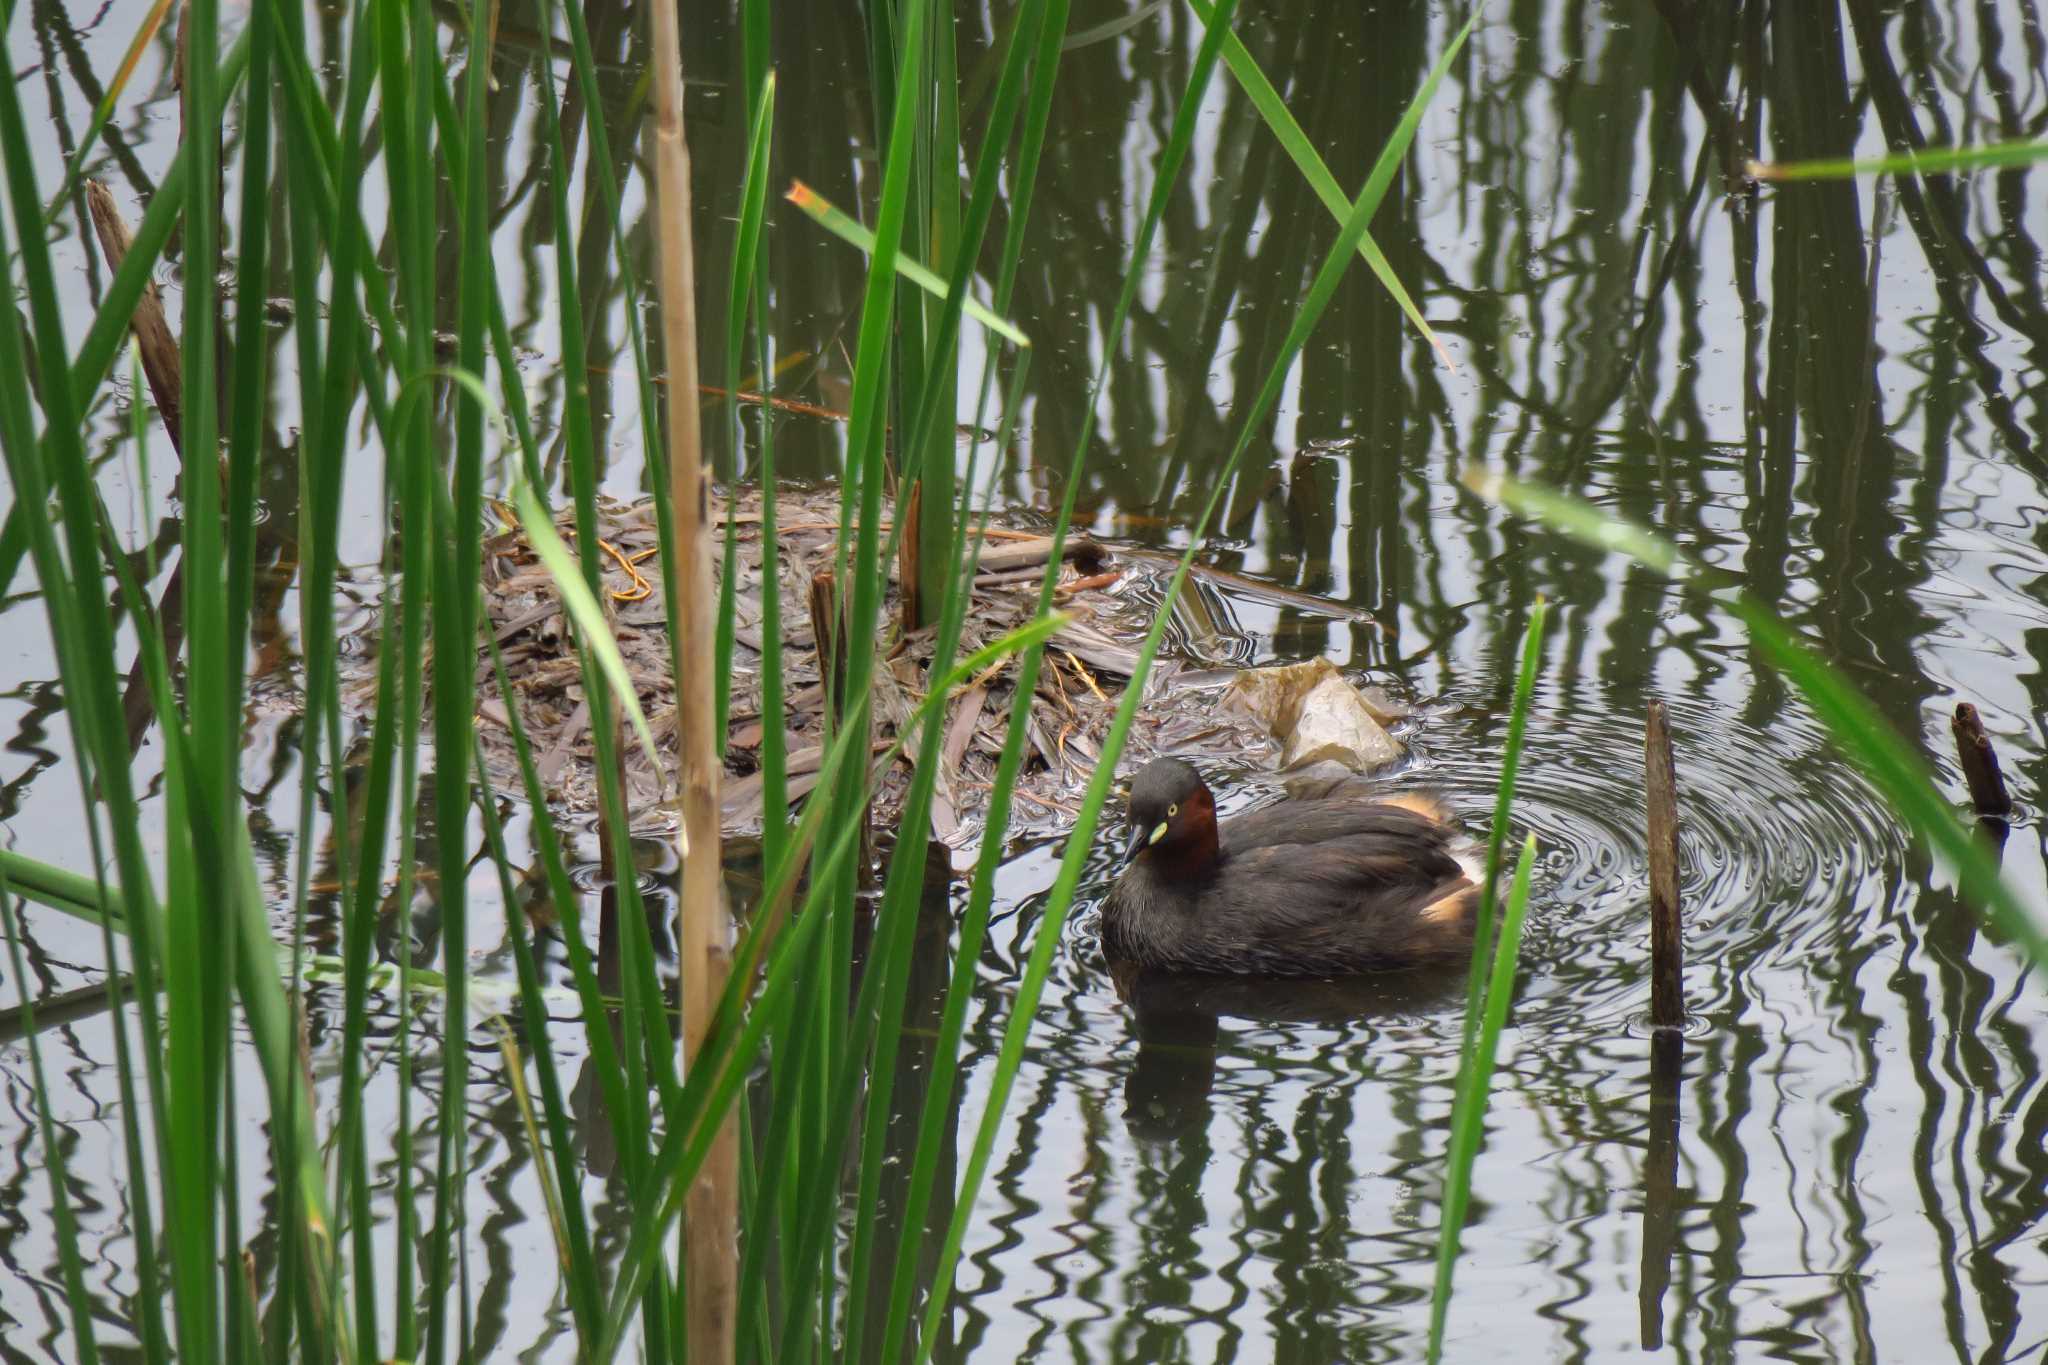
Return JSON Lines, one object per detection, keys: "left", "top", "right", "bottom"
{"left": 1466, "top": 473, "right": 2048, "bottom": 964}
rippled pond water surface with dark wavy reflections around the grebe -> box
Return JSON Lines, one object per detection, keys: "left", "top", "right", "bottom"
{"left": 0, "top": 0, "right": 2048, "bottom": 1361}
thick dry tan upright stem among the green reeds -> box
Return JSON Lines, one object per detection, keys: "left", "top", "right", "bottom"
{"left": 653, "top": 0, "right": 739, "bottom": 1365}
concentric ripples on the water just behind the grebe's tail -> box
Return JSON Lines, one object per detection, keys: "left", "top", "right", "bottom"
{"left": 1413, "top": 698, "right": 1907, "bottom": 1031}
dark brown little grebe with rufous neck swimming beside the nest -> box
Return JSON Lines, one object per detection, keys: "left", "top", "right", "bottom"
{"left": 1102, "top": 759, "right": 1485, "bottom": 976}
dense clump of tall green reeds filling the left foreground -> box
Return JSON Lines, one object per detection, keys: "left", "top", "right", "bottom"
{"left": 0, "top": 0, "right": 1490, "bottom": 1359}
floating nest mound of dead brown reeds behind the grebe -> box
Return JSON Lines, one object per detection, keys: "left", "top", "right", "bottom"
{"left": 376, "top": 487, "right": 1274, "bottom": 849}
